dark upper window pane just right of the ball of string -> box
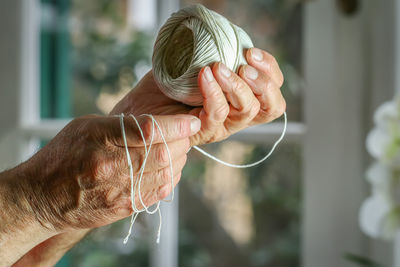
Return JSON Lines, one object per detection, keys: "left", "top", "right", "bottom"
{"left": 181, "top": 0, "right": 304, "bottom": 121}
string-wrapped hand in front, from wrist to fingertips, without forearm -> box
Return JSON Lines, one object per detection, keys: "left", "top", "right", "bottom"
{"left": 25, "top": 115, "right": 200, "bottom": 230}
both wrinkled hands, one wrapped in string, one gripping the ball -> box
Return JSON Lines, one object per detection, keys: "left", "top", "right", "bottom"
{"left": 7, "top": 48, "right": 285, "bottom": 266}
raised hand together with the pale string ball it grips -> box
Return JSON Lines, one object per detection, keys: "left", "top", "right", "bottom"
{"left": 112, "top": 5, "right": 286, "bottom": 146}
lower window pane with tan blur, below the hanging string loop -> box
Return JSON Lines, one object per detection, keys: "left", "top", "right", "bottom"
{"left": 179, "top": 141, "right": 302, "bottom": 267}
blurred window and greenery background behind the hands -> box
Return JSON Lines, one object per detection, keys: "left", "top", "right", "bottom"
{"left": 0, "top": 0, "right": 400, "bottom": 267}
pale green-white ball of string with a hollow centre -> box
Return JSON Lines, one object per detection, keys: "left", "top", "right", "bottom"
{"left": 152, "top": 4, "right": 253, "bottom": 106}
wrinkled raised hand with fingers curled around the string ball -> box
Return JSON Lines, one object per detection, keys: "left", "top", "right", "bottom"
{"left": 111, "top": 48, "right": 286, "bottom": 146}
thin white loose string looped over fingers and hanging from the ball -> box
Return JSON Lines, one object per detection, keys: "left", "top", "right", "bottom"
{"left": 119, "top": 112, "right": 287, "bottom": 244}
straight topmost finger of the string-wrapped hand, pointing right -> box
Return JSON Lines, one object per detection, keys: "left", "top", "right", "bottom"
{"left": 108, "top": 114, "right": 201, "bottom": 147}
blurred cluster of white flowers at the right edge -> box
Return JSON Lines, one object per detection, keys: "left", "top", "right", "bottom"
{"left": 359, "top": 95, "right": 400, "bottom": 239}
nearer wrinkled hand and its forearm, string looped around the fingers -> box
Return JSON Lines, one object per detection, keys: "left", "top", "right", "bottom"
{"left": 0, "top": 115, "right": 200, "bottom": 266}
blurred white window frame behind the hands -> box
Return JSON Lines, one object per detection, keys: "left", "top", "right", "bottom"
{"left": 0, "top": 0, "right": 400, "bottom": 267}
